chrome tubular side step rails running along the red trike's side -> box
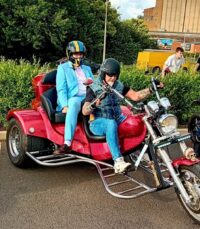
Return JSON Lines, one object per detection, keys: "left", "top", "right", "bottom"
{"left": 26, "top": 150, "right": 157, "bottom": 199}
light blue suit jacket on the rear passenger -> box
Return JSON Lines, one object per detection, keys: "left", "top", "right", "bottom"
{"left": 56, "top": 61, "right": 94, "bottom": 111}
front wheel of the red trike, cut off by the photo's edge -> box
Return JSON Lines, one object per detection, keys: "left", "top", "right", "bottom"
{"left": 176, "top": 164, "right": 200, "bottom": 224}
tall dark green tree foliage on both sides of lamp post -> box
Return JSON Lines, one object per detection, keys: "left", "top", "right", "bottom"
{"left": 0, "top": 0, "right": 155, "bottom": 63}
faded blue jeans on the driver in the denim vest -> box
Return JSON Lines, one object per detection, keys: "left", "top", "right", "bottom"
{"left": 90, "top": 115, "right": 126, "bottom": 161}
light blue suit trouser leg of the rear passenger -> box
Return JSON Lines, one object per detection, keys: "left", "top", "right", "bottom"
{"left": 64, "top": 96, "right": 85, "bottom": 141}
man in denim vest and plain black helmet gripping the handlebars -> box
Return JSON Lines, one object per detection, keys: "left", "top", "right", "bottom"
{"left": 82, "top": 58, "right": 163, "bottom": 173}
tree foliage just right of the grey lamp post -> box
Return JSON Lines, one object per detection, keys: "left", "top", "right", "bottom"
{"left": 108, "top": 19, "right": 156, "bottom": 64}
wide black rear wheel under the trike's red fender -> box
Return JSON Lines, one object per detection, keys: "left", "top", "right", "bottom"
{"left": 6, "top": 119, "right": 45, "bottom": 168}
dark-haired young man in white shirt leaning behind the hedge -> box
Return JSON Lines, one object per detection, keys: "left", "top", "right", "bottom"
{"left": 162, "top": 47, "right": 185, "bottom": 76}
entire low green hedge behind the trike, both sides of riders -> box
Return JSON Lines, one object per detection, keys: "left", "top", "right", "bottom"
{"left": 0, "top": 58, "right": 200, "bottom": 127}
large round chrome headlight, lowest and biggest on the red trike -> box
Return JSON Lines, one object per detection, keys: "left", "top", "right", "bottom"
{"left": 158, "top": 114, "right": 178, "bottom": 135}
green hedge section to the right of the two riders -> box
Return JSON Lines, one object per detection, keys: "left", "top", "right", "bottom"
{"left": 120, "top": 67, "right": 200, "bottom": 125}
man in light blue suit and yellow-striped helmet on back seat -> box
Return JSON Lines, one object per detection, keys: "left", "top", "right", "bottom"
{"left": 54, "top": 40, "right": 94, "bottom": 154}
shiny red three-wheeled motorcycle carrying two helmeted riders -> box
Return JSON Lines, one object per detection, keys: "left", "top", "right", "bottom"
{"left": 6, "top": 71, "right": 200, "bottom": 223}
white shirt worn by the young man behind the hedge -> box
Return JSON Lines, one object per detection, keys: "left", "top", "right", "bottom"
{"left": 165, "top": 54, "right": 185, "bottom": 73}
